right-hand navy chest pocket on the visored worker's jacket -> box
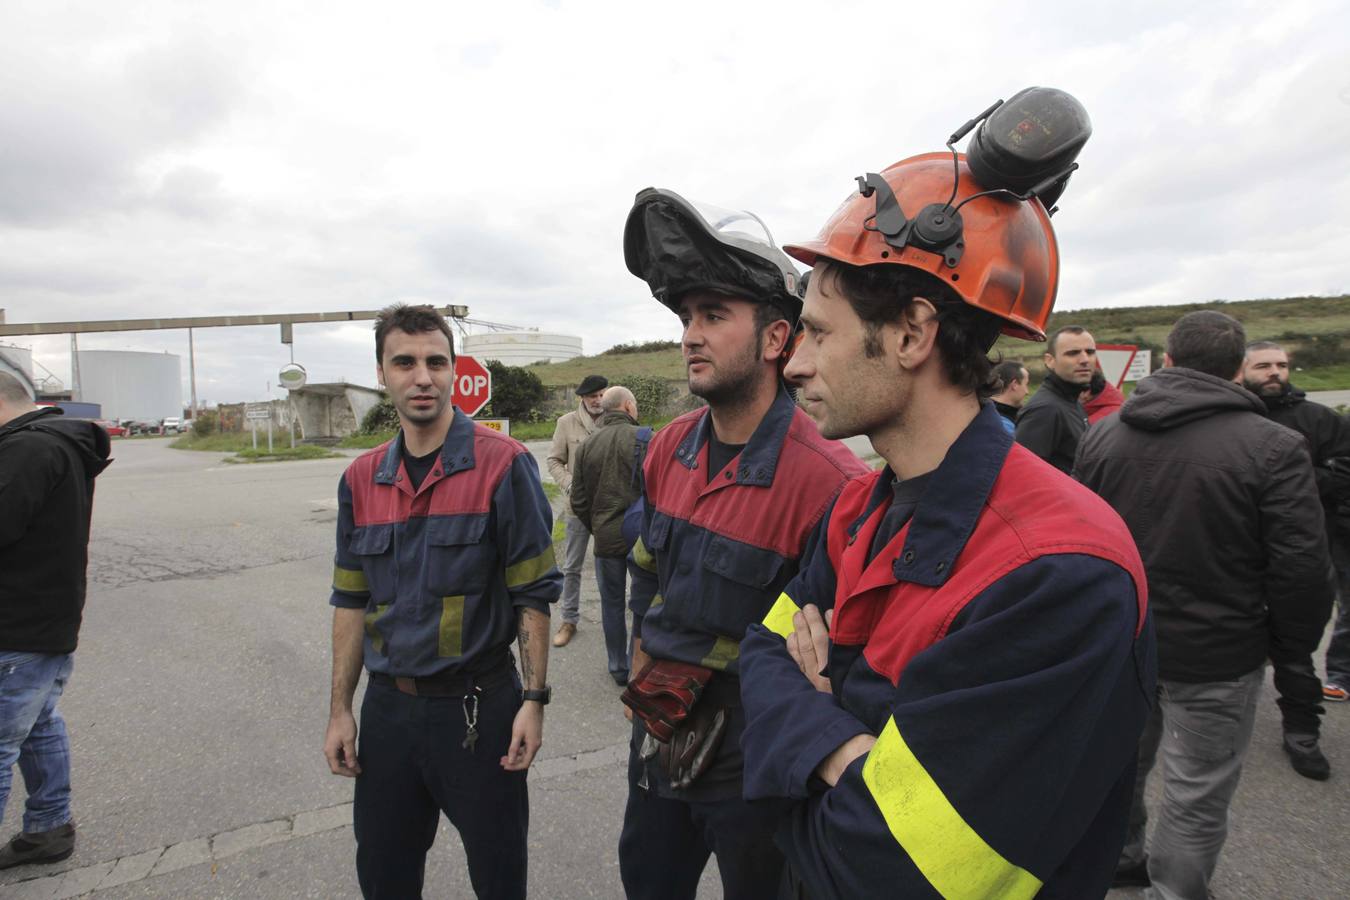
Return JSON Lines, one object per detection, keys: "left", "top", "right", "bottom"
{"left": 695, "top": 536, "right": 787, "bottom": 640}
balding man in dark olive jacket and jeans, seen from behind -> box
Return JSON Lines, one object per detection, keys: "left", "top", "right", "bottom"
{"left": 571, "top": 385, "right": 643, "bottom": 685}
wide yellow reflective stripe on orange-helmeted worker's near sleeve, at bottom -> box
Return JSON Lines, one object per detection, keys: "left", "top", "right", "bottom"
{"left": 863, "top": 718, "right": 1041, "bottom": 900}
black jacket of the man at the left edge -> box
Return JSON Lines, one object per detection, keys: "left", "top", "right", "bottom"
{"left": 0, "top": 409, "right": 109, "bottom": 653}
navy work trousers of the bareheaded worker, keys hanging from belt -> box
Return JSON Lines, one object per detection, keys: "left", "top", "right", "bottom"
{"left": 352, "top": 679, "right": 529, "bottom": 900}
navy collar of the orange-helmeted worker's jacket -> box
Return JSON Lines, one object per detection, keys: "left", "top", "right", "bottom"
{"left": 848, "top": 403, "right": 1013, "bottom": 587}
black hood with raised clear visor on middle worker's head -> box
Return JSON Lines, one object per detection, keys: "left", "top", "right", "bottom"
{"left": 624, "top": 188, "right": 802, "bottom": 322}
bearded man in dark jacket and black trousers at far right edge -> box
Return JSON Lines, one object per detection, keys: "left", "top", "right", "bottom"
{"left": 1242, "top": 340, "right": 1350, "bottom": 780}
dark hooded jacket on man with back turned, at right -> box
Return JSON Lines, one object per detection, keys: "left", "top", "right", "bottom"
{"left": 1075, "top": 368, "right": 1332, "bottom": 681}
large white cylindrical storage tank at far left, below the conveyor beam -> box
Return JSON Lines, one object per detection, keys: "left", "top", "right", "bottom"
{"left": 77, "top": 349, "right": 182, "bottom": 422}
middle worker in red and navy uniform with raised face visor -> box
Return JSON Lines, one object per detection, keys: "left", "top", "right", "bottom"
{"left": 618, "top": 189, "right": 867, "bottom": 899}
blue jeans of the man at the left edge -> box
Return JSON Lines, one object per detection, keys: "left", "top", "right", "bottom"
{"left": 0, "top": 650, "right": 74, "bottom": 834}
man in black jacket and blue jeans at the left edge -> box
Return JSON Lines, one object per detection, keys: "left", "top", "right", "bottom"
{"left": 0, "top": 372, "right": 108, "bottom": 869}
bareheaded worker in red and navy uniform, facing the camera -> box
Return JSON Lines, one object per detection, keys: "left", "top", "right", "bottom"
{"left": 324, "top": 305, "right": 562, "bottom": 899}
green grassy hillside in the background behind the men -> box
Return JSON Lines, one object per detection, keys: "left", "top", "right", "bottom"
{"left": 529, "top": 296, "right": 1350, "bottom": 390}
